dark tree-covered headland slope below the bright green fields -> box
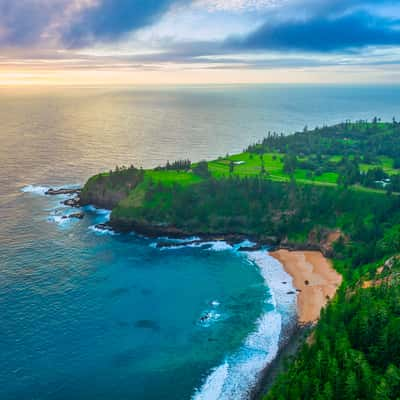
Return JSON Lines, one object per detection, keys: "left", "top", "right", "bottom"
{"left": 111, "top": 178, "right": 400, "bottom": 264}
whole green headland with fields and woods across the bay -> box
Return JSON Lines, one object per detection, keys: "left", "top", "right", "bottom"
{"left": 82, "top": 121, "right": 400, "bottom": 265}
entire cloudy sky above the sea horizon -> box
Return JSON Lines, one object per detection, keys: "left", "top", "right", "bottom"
{"left": 0, "top": 0, "right": 400, "bottom": 85}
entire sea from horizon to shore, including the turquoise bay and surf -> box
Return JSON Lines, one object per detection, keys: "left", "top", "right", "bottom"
{"left": 0, "top": 85, "right": 400, "bottom": 400}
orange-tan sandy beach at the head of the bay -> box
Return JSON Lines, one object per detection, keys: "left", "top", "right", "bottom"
{"left": 270, "top": 250, "right": 342, "bottom": 324}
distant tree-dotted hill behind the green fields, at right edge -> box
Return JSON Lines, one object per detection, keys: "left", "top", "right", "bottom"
{"left": 247, "top": 118, "right": 400, "bottom": 192}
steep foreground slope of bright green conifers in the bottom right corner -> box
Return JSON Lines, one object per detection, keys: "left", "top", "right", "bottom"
{"left": 264, "top": 261, "right": 400, "bottom": 400}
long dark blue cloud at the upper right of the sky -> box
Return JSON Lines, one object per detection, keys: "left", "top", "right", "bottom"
{"left": 230, "top": 12, "right": 400, "bottom": 52}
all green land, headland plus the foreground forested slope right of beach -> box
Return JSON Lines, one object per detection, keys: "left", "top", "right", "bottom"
{"left": 82, "top": 118, "right": 400, "bottom": 400}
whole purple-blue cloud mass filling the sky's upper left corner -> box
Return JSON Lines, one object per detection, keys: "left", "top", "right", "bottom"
{"left": 0, "top": 0, "right": 184, "bottom": 47}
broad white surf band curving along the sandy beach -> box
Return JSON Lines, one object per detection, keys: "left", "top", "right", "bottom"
{"left": 192, "top": 251, "right": 296, "bottom": 400}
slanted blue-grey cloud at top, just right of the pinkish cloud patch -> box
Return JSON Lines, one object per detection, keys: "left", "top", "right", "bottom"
{"left": 62, "top": 0, "right": 183, "bottom": 47}
